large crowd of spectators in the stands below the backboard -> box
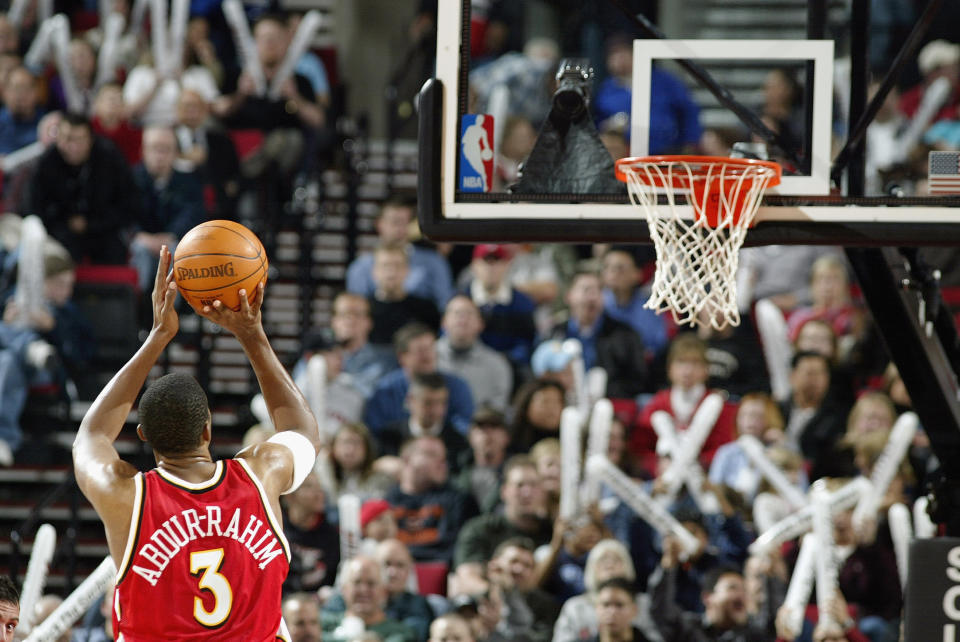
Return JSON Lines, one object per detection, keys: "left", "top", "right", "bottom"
{"left": 219, "top": 200, "right": 924, "bottom": 641}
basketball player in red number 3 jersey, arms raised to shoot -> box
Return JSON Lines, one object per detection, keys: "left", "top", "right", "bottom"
{"left": 73, "top": 247, "right": 319, "bottom": 642}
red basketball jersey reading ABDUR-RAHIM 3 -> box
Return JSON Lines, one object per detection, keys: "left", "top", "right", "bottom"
{"left": 113, "top": 459, "right": 290, "bottom": 642}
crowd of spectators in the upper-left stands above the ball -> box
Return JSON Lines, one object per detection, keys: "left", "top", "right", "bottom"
{"left": 0, "top": 3, "right": 334, "bottom": 465}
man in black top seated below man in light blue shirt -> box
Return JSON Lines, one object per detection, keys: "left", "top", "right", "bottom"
{"left": 368, "top": 245, "right": 440, "bottom": 345}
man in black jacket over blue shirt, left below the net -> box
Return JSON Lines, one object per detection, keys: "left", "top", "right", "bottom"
{"left": 549, "top": 272, "right": 648, "bottom": 399}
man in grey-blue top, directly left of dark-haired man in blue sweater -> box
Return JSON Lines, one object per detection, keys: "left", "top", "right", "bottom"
{"left": 330, "top": 292, "right": 397, "bottom": 399}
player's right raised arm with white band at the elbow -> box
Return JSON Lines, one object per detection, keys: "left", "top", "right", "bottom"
{"left": 201, "top": 283, "right": 320, "bottom": 495}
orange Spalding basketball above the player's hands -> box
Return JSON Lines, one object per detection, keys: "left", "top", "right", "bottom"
{"left": 173, "top": 221, "right": 267, "bottom": 312}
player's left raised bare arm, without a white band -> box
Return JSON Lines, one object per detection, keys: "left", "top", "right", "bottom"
{"left": 73, "top": 246, "right": 180, "bottom": 504}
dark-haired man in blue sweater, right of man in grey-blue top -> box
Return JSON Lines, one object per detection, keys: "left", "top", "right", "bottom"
{"left": 364, "top": 323, "right": 474, "bottom": 435}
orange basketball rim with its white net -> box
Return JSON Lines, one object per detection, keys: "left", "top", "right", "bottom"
{"left": 620, "top": 160, "right": 776, "bottom": 330}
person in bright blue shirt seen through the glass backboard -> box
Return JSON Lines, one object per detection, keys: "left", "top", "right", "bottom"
{"left": 591, "top": 35, "right": 703, "bottom": 154}
